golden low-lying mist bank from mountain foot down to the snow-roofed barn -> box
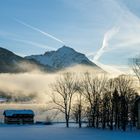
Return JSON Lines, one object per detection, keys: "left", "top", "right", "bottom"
{"left": 0, "top": 65, "right": 136, "bottom": 120}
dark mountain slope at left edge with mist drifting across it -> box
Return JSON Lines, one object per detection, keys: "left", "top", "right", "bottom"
{"left": 0, "top": 47, "right": 48, "bottom": 73}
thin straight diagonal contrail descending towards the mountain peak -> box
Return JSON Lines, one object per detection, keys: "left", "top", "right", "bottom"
{"left": 15, "top": 19, "right": 65, "bottom": 45}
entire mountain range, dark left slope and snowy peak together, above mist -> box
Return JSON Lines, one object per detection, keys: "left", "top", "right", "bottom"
{"left": 0, "top": 46, "right": 102, "bottom": 73}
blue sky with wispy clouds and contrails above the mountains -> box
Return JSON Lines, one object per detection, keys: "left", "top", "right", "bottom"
{"left": 0, "top": 0, "right": 140, "bottom": 66}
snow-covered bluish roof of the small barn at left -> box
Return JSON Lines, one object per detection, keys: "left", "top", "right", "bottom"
{"left": 3, "top": 110, "right": 34, "bottom": 117}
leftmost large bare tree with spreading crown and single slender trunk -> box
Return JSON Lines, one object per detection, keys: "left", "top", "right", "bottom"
{"left": 52, "top": 73, "right": 77, "bottom": 127}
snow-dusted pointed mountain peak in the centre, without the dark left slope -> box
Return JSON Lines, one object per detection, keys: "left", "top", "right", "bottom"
{"left": 25, "top": 46, "right": 101, "bottom": 70}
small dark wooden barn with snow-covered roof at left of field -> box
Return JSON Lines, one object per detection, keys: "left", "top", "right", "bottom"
{"left": 3, "top": 110, "right": 34, "bottom": 124}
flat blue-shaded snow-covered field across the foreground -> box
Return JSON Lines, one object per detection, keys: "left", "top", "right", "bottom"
{"left": 0, "top": 125, "right": 140, "bottom": 140}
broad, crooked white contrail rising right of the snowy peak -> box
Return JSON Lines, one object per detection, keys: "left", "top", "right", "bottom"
{"left": 93, "top": 27, "right": 119, "bottom": 61}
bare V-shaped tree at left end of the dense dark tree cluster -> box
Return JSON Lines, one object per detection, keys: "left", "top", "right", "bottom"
{"left": 82, "top": 73, "right": 107, "bottom": 127}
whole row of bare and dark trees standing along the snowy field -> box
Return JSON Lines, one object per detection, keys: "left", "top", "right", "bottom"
{"left": 51, "top": 72, "right": 138, "bottom": 131}
